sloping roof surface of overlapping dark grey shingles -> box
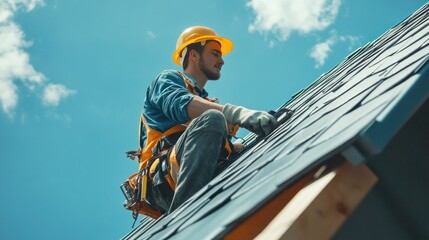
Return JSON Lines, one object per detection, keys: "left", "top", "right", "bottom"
{"left": 124, "top": 4, "right": 429, "bottom": 239}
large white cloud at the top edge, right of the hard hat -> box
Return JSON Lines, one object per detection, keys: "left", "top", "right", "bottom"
{"left": 247, "top": 0, "right": 341, "bottom": 41}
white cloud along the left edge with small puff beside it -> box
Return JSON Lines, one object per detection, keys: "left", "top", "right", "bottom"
{"left": 0, "top": 0, "right": 74, "bottom": 116}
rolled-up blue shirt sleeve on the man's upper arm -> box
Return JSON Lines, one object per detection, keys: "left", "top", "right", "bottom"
{"left": 149, "top": 71, "right": 194, "bottom": 123}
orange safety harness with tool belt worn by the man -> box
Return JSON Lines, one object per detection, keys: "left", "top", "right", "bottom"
{"left": 121, "top": 71, "right": 239, "bottom": 222}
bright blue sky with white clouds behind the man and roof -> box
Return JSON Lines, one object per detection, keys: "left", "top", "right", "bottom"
{"left": 0, "top": 0, "right": 425, "bottom": 239}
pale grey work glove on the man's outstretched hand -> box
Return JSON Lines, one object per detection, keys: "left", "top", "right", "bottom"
{"left": 222, "top": 104, "right": 277, "bottom": 136}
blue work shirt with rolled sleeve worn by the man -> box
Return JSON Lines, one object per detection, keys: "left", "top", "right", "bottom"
{"left": 140, "top": 70, "right": 208, "bottom": 147}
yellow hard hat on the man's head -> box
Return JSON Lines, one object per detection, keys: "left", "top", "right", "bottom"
{"left": 172, "top": 26, "right": 234, "bottom": 66}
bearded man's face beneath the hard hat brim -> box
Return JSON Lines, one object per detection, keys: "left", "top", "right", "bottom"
{"left": 198, "top": 41, "right": 224, "bottom": 80}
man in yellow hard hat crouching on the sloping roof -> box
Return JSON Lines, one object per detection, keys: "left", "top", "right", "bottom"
{"left": 139, "top": 26, "right": 277, "bottom": 216}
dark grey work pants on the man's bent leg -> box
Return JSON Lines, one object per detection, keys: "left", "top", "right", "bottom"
{"left": 147, "top": 110, "right": 227, "bottom": 212}
